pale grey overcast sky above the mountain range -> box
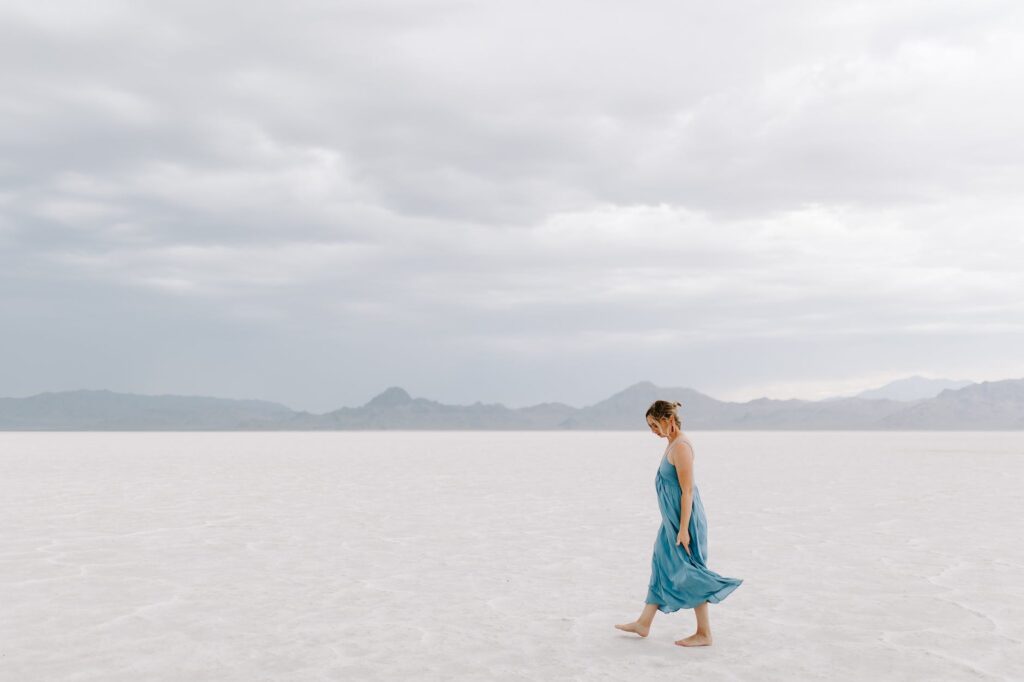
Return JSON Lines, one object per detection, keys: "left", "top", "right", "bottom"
{"left": 0, "top": 0, "right": 1024, "bottom": 412}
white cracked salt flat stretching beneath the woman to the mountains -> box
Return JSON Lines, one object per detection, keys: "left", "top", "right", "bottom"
{"left": 0, "top": 431, "right": 1024, "bottom": 682}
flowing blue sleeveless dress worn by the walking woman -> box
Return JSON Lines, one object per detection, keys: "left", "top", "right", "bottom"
{"left": 646, "top": 440, "right": 743, "bottom": 613}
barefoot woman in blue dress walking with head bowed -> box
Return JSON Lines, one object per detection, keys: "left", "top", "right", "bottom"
{"left": 615, "top": 400, "right": 743, "bottom": 646}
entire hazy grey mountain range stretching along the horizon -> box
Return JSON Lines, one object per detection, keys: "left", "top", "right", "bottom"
{"left": 0, "top": 379, "right": 1024, "bottom": 431}
